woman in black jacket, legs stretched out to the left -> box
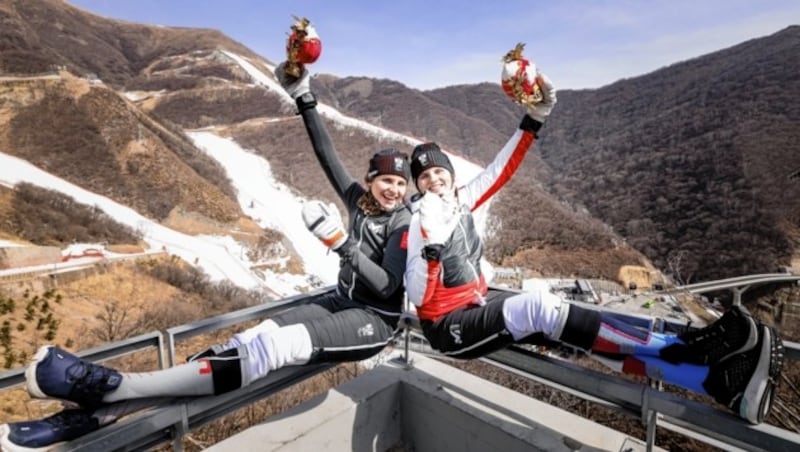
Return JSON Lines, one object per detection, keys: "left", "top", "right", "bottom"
{"left": 0, "top": 61, "right": 411, "bottom": 450}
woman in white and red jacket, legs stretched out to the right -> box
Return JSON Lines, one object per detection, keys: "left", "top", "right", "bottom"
{"left": 405, "top": 69, "right": 783, "bottom": 423}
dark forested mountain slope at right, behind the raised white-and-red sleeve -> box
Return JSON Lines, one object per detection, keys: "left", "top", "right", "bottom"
{"left": 312, "top": 26, "right": 800, "bottom": 282}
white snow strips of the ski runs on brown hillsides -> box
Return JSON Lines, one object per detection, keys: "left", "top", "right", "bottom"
{"left": 0, "top": 48, "right": 500, "bottom": 296}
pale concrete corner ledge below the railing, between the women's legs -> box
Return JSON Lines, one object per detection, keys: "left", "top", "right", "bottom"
{"left": 207, "top": 354, "right": 646, "bottom": 452}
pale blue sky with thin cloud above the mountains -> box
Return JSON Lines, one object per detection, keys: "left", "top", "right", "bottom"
{"left": 69, "top": 0, "right": 800, "bottom": 89}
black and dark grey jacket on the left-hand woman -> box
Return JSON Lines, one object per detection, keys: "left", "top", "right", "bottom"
{"left": 297, "top": 93, "right": 411, "bottom": 315}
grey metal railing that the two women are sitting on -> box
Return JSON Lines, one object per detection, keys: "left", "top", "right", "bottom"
{"left": 0, "top": 288, "right": 800, "bottom": 451}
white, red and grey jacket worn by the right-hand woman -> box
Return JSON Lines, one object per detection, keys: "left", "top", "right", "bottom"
{"left": 405, "top": 115, "right": 542, "bottom": 320}
